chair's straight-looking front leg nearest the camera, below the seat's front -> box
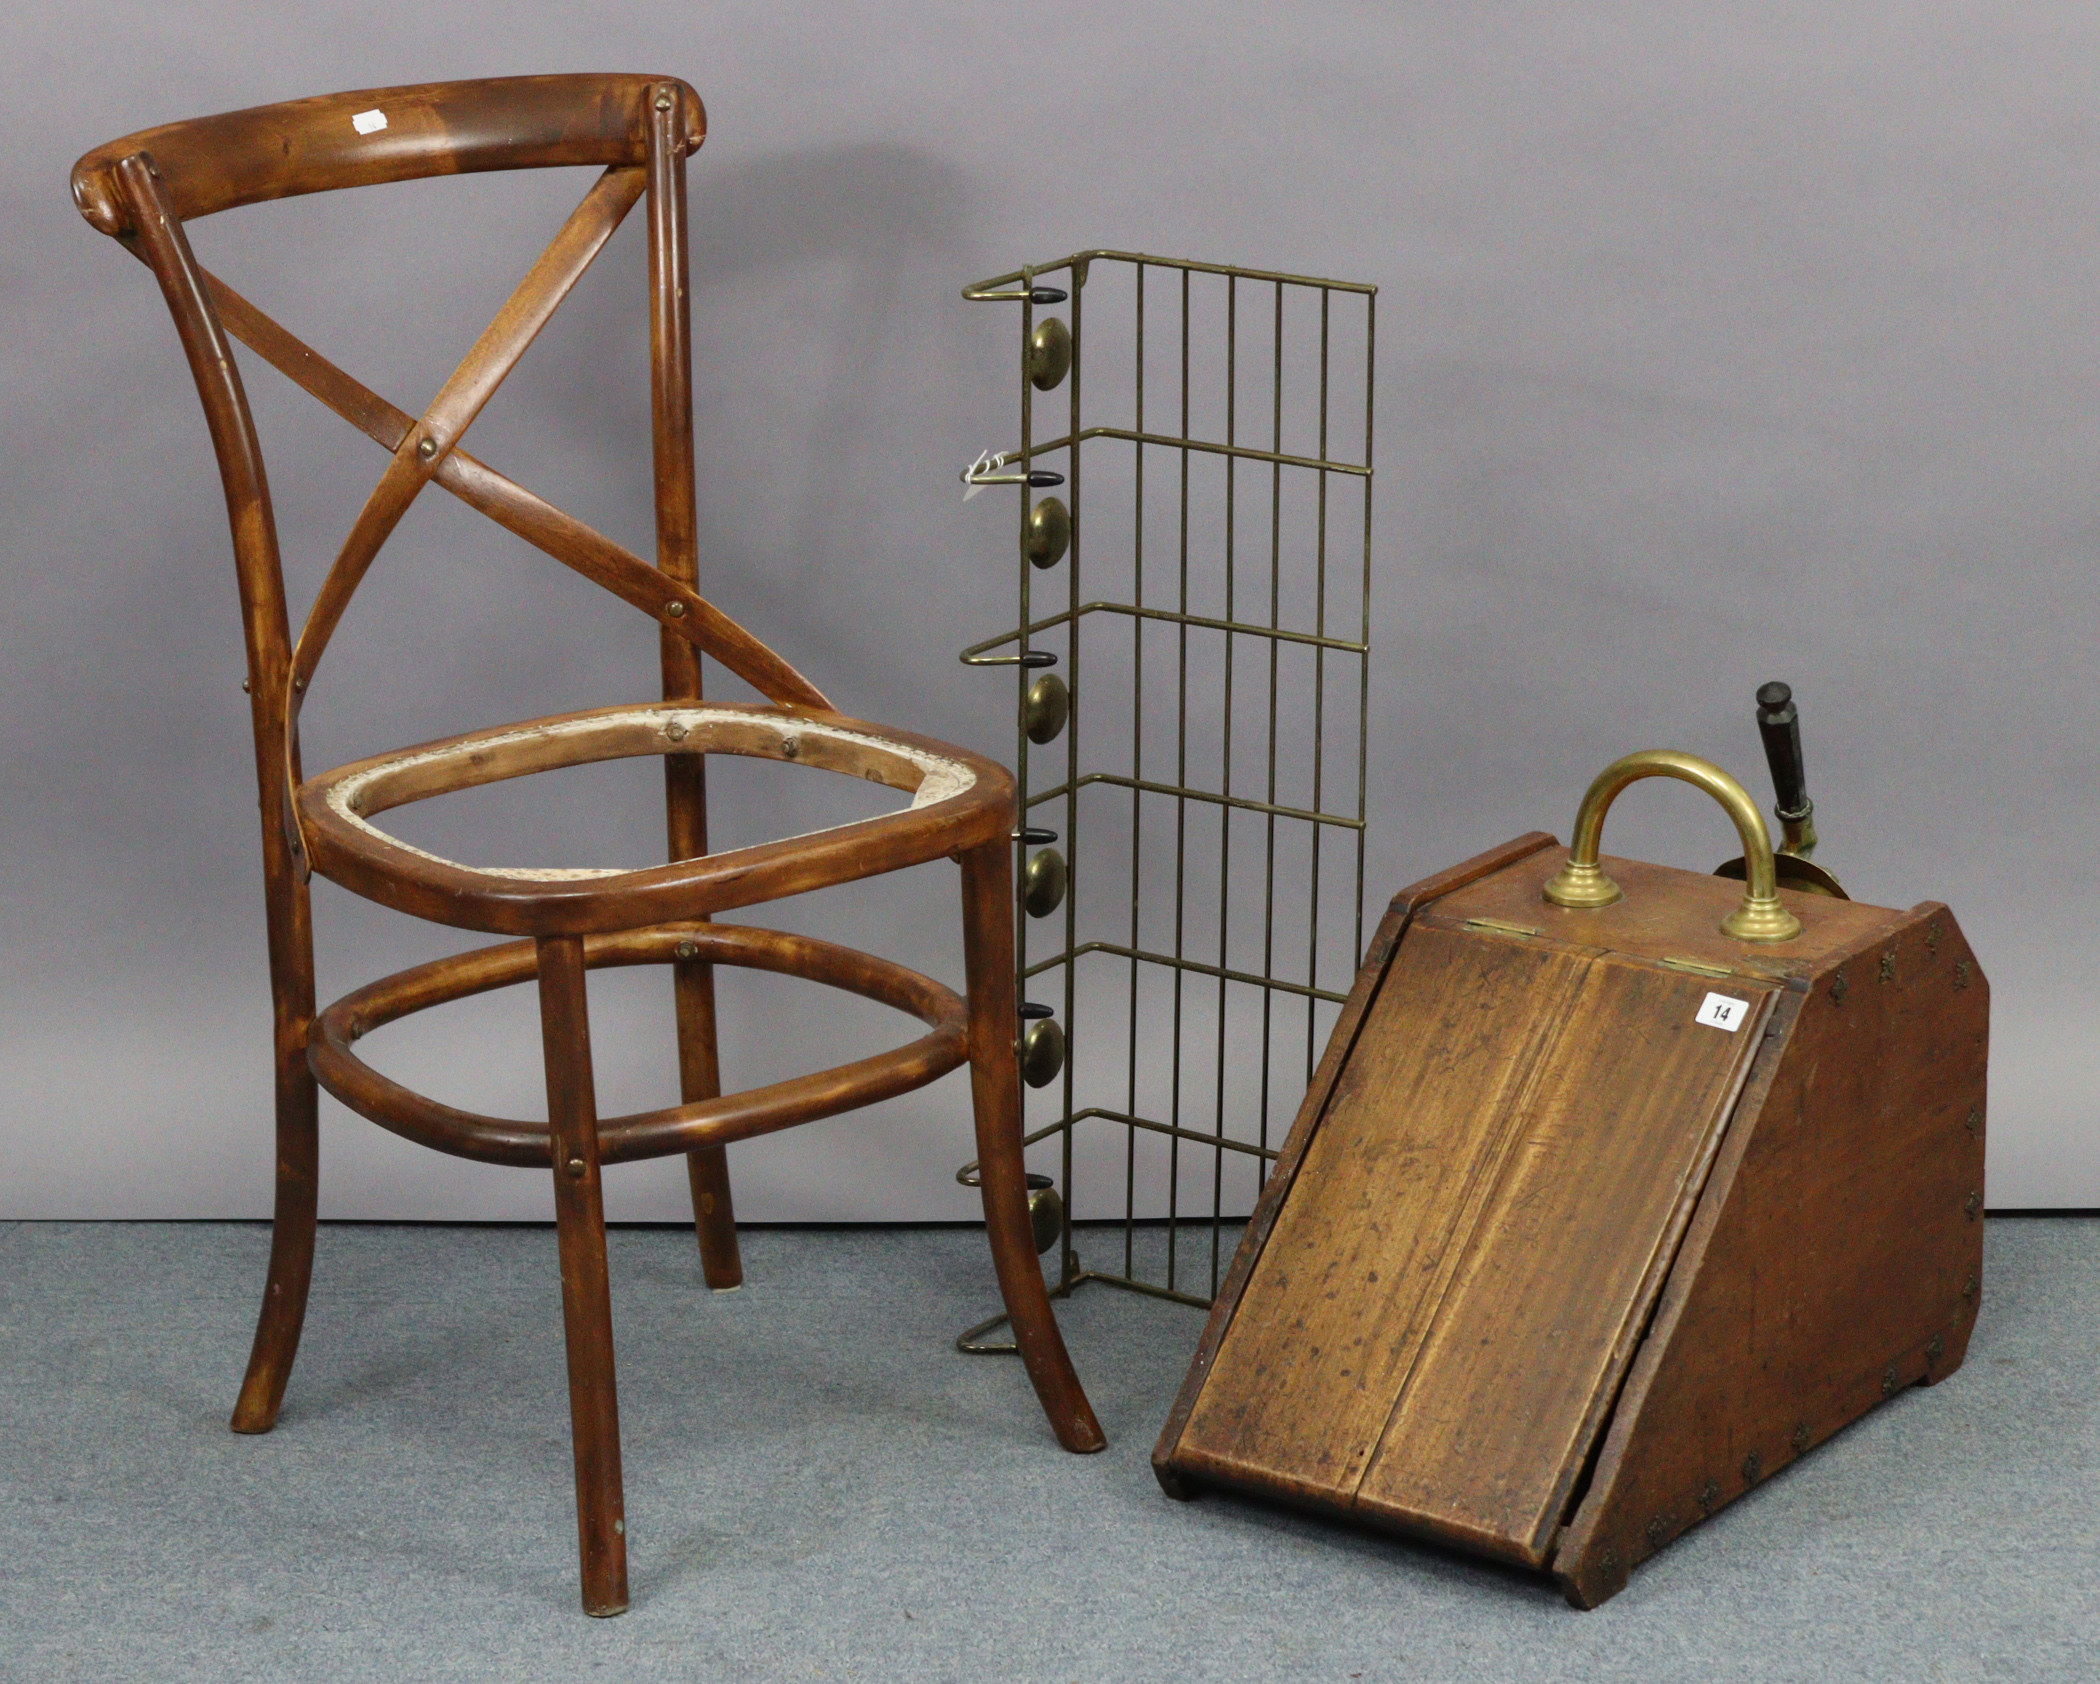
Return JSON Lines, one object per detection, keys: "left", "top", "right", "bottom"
{"left": 540, "top": 936, "right": 628, "bottom": 1615}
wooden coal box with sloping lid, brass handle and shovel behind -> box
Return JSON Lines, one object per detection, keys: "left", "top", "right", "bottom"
{"left": 1153, "top": 687, "right": 1989, "bottom": 1608}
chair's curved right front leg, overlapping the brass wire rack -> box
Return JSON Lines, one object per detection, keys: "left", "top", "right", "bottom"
{"left": 962, "top": 838, "right": 1109, "bottom": 1451}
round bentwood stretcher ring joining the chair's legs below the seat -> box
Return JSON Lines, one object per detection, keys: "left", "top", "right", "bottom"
{"left": 307, "top": 924, "right": 970, "bottom": 1167}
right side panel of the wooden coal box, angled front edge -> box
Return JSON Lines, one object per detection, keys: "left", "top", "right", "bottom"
{"left": 1554, "top": 903, "right": 1991, "bottom": 1606}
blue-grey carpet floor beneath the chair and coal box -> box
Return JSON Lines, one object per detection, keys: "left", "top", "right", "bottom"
{"left": 0, "top": 1218, "right": 2100, "bottom": 1684}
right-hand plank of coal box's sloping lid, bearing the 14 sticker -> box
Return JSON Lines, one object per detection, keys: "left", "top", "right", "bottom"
{"left": 1357, "top": 953, "right": 1772, "bottom": 1566}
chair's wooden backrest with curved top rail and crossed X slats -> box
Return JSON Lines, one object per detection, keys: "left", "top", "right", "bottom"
{"left": 74, "top": 73, "right": 832, "bottom": 876}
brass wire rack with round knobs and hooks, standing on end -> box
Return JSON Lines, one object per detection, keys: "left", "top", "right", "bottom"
{"left": 956, "top": 250, "right": 1378, "bottom": 1354}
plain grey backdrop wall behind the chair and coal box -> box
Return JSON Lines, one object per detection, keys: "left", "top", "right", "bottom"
{"left": 0, "top": 0, "right": 2100, "bottom": 1218}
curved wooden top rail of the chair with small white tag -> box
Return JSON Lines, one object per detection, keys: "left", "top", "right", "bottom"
{"left": 74, "top": 71, "right": 708, "bottom": 235}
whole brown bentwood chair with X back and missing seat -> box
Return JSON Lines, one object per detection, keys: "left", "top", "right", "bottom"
{"left": 74, "top": 76, "right": 1103, "bottom": 1615}
